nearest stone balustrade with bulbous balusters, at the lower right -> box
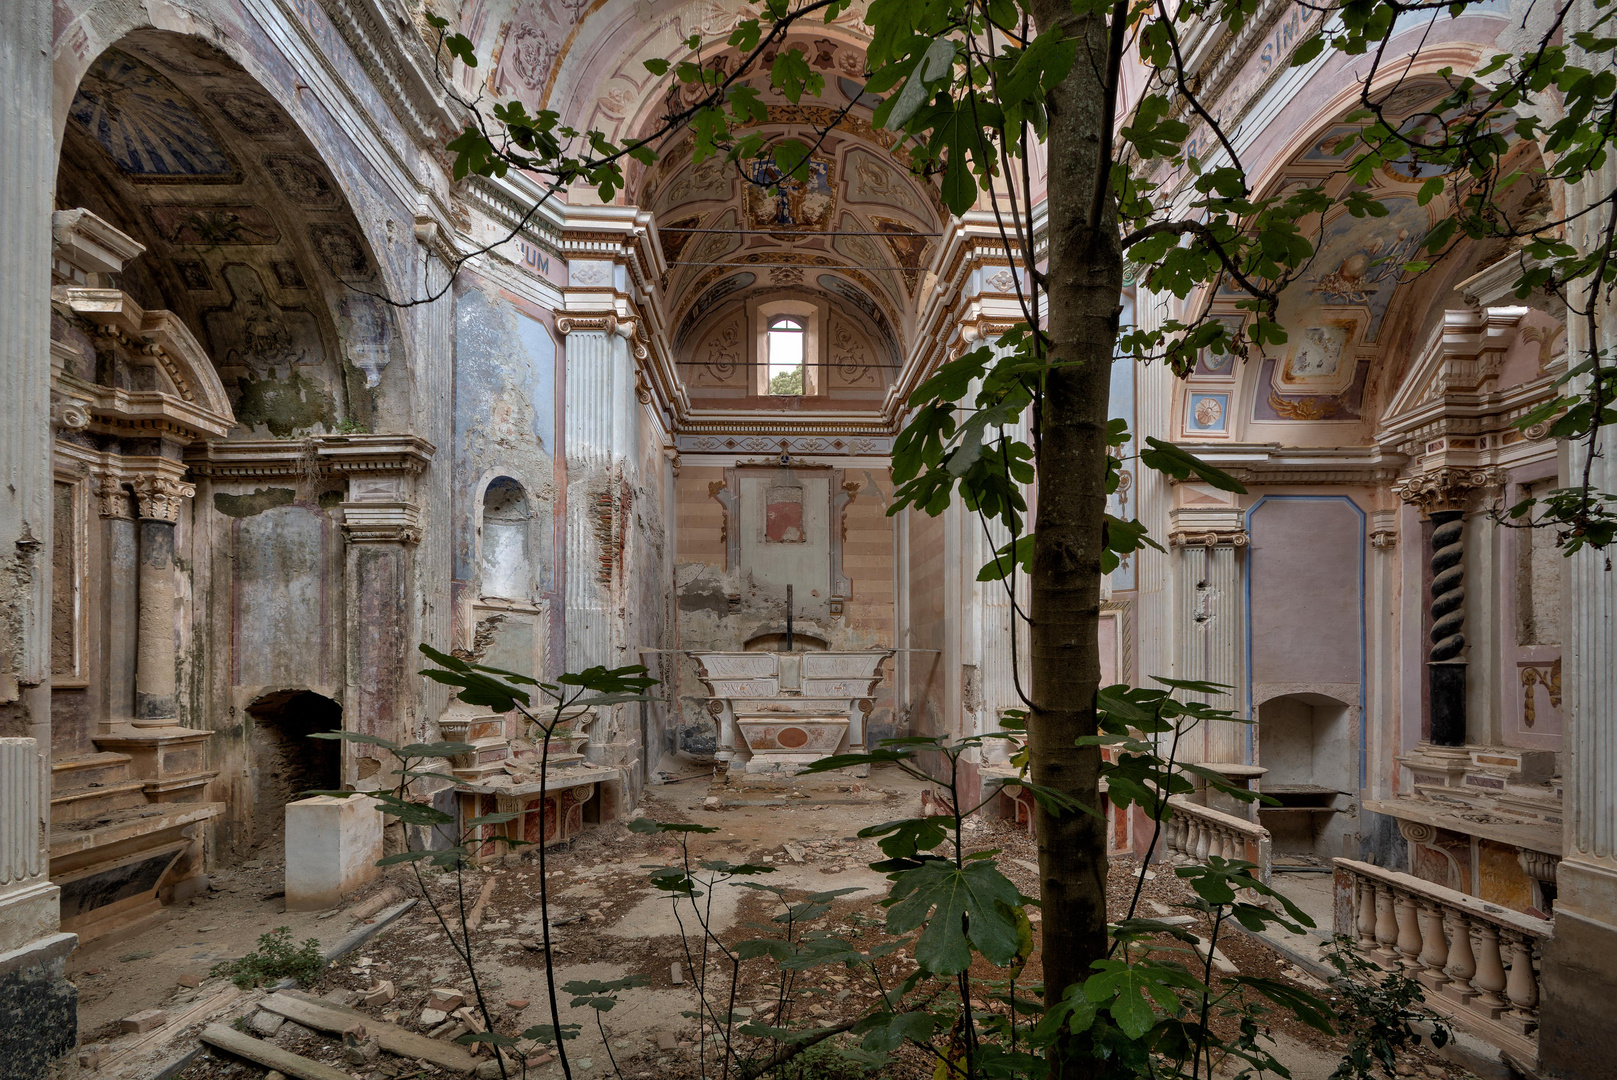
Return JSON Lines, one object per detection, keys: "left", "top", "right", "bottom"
{"left": 1334, "top": 859, "right": 1556, "bottom": 1061}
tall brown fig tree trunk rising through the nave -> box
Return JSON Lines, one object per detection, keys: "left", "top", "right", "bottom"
{"left": 1028, "top": 0, "right": 1122, "bottom": 1054}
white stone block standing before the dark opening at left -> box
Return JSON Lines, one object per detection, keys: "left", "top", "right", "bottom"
{"left": 286, "top": 795, "right": 382, "bottom": 912}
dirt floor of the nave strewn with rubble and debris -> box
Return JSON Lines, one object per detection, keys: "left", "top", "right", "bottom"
{"left": 73, "top": 770, "right": 1465, "bottom": 1080}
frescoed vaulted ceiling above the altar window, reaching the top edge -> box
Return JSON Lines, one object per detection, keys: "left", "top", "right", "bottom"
{"left": 458, "top": 0, "right": 946, "bottom": 400}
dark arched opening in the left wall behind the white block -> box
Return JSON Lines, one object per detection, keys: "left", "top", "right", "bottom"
{"left": 247, "top": 690, "right": 343, "bottom": 859}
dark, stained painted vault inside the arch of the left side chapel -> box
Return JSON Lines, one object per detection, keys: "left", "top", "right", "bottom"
{"left": 57, "top": 26, "right": 409, "bottom": 437}
